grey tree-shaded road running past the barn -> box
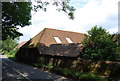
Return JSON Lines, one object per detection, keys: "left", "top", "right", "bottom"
{"left": 0, "top": 55, "right": 72, "bottom": 81}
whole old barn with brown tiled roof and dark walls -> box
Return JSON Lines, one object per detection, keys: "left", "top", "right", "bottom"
{"left": 16, "top": 28, "right": 85, "bottom": 63}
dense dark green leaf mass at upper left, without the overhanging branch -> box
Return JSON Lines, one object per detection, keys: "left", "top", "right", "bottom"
{"left": 2, "top": 2, "right": 32, "bottom": 40}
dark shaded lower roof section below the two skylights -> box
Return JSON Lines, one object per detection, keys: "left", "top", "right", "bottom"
{"left": 38, "top": 43, "right": 84, "bottom": 57}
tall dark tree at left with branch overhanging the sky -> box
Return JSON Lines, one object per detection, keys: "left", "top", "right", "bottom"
{"left": 2, "top": 0, "right": 75, "bottom": 40}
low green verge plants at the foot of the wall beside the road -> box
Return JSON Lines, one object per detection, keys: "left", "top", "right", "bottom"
{"left": 52, "top": 68, "right": 107, "bottom": 81}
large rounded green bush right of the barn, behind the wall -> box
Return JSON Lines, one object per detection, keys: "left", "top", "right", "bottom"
{"left": 81, "top": 26, "right": 117, "bottom": 60}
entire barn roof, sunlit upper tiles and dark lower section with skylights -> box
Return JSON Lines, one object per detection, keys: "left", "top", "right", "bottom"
{"left": 22, "top": 28, "right": 84, "bottom": 57}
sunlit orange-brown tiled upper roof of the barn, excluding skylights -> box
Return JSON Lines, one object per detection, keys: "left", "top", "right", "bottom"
{"left": 21, "top": 28, "right": 84, "bottom": 47}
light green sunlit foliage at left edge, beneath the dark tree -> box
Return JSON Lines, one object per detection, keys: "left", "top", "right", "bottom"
{"left": 2, "top": 37, "right": 18, "bottom": 52}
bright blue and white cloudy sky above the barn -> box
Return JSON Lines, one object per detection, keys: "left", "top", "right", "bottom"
{"left": 18, "top": 0, "right": 120, "bottom": 43}
